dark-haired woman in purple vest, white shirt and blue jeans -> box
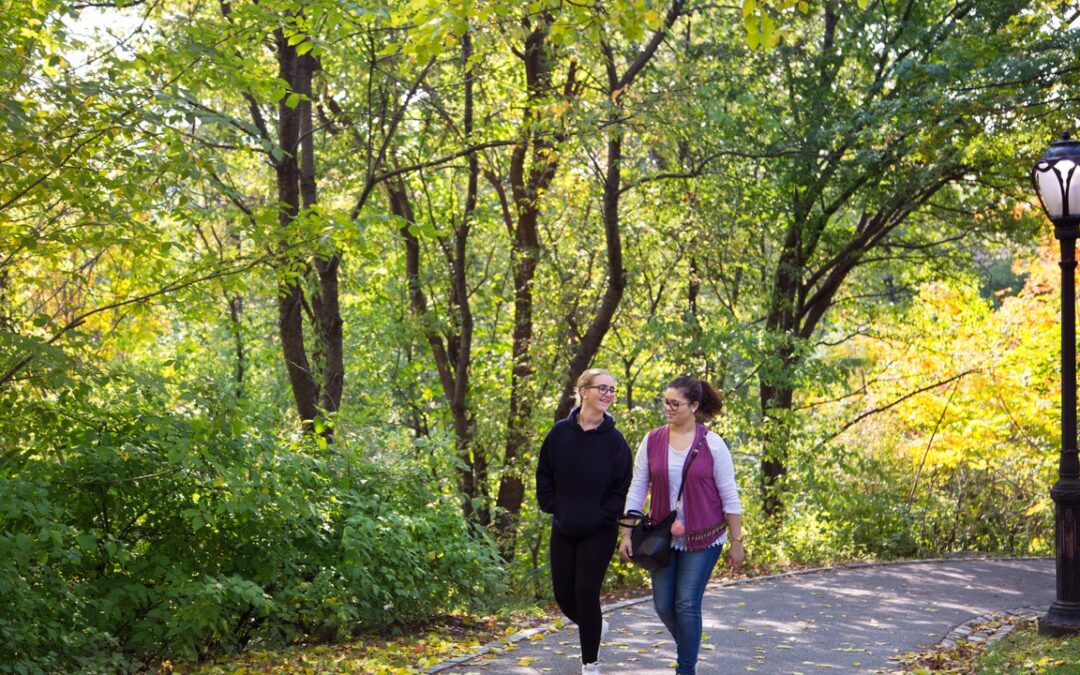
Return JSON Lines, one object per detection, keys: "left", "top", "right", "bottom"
{"left": 619, "top": 375, "right": 746, "bottom": 675}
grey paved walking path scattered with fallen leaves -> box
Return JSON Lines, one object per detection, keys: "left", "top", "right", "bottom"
{"left": 431, "top": 558, "right": 1056, "bottom": 675}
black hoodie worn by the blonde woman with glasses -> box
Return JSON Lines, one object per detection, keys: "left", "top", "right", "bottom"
{"left": 537, "top": 408, "right": 634, "bottom": 537}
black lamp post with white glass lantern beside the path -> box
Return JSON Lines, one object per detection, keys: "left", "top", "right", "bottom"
{"left": 1031, "top": 134, "right": 1080, "bottom": 635}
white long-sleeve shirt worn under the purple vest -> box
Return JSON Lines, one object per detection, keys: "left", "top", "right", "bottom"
{"left": 623, "top": 431, "right": 742, "bottom": 551}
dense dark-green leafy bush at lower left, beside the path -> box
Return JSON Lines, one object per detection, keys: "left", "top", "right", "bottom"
{"left": 0, "top": 365, "right": 499, "bottom": 672}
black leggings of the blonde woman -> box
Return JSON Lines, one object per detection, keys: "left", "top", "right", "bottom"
{"left": 551, "top": 525, "right": 616, "bottom": 663}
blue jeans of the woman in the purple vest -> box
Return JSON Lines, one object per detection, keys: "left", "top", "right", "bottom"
{"left": 652, "top": 546, "right": 724, "bottom": 675}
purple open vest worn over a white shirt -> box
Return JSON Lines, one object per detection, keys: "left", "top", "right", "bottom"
{"left": 647, "top": 424, "right": 727, "bottom": 551}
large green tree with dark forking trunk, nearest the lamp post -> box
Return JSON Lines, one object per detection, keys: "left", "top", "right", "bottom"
{"left": 678, "top": 1, "right": 1077, "bottom": 513}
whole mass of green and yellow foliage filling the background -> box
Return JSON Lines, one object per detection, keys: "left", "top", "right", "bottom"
{"left": 0, "top": 0, "right": 1077, "bottom": 672}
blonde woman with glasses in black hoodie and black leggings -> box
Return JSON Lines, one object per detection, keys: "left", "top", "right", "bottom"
{"left": 537, "top": 368, "right": 632, "bottom": 675}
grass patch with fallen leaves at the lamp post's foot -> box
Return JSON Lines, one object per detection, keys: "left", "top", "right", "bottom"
{"left": 972, "top": 621, "right": 1080, "bottom": 675}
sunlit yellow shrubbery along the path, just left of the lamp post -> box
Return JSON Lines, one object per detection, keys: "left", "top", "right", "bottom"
{"left": 747, "top": 258, "right": 1059, "bottom": 563}
